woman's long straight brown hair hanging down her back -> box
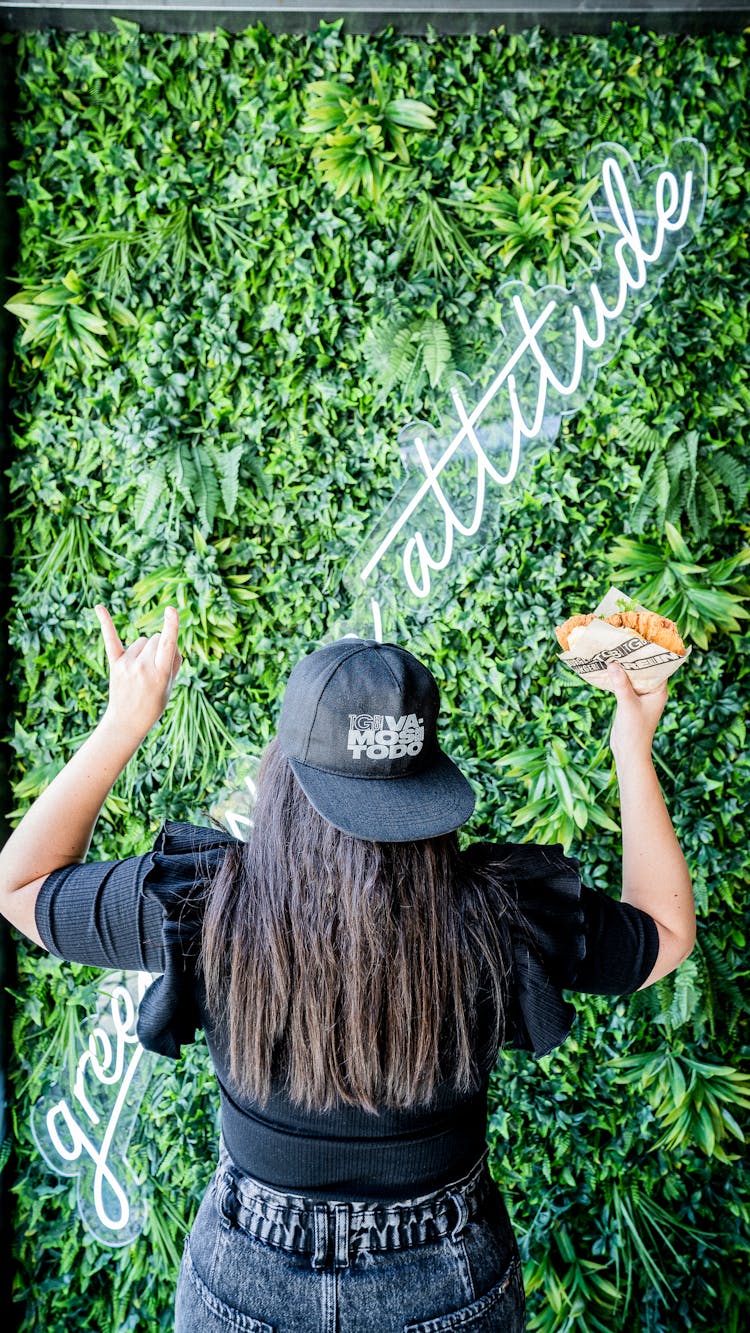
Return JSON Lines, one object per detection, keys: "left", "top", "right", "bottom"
{"left": 198, "top": 740, "right": 514, "bottom": 1112}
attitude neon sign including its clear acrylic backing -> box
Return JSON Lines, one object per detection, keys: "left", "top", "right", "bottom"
{"left": 346, "top": 139, "right": 707, "bottom": 637}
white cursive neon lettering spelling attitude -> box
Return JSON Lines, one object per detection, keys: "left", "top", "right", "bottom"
{"left": 356, "top": 140, "right": 706, "bottom": 600}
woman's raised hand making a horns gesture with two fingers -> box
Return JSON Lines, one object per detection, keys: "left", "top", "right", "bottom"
{"left": 93, "top": 604, "right": 183, "bottom": 742}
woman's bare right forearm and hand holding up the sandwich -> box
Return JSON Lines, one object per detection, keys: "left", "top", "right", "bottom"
{"left": 609, "top": 667, "right": 695, "bottom": 990}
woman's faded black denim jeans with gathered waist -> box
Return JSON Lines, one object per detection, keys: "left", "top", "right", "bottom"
{"left": 175, "top": 1146, "right": 526, "bottom": 1333}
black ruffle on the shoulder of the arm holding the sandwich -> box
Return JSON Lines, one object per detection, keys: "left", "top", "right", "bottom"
{"left": 468, "top": 842, "right": 586, "bottom": 1056}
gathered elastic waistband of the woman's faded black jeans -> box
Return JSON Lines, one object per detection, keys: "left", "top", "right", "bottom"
{"left": 214, "top": 1144, "right": 496, "bottom": 1269}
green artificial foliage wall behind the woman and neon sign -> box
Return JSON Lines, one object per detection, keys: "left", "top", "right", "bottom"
{"left": 3, "top": 19, "right": 750, "bottom": 1333}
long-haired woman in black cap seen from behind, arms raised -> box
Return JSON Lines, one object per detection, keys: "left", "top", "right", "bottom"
{"left": 0, "top": 607, "right": 695, "bottom": 1333}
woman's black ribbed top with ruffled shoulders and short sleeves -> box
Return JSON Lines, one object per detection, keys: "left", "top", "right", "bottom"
{"left": 36, "top": 820, "right": 658, "bottom": 1198}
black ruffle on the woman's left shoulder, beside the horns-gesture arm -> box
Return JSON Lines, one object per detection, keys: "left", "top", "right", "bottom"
{"left": 137, "top": 820, "right": 240, "bottom": 1060}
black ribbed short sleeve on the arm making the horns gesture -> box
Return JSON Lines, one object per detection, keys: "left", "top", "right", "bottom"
{"left": 36, "top": 852, "right": 164, "bottom": 972}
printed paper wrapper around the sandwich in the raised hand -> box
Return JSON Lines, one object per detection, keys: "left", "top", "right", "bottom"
{"left": 560, "top": 588, "right": 691, "bottom": 694}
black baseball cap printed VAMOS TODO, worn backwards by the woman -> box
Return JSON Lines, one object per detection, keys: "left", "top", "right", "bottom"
{"left": 278, "top": 639, "right": 474, "bottom": 842}
